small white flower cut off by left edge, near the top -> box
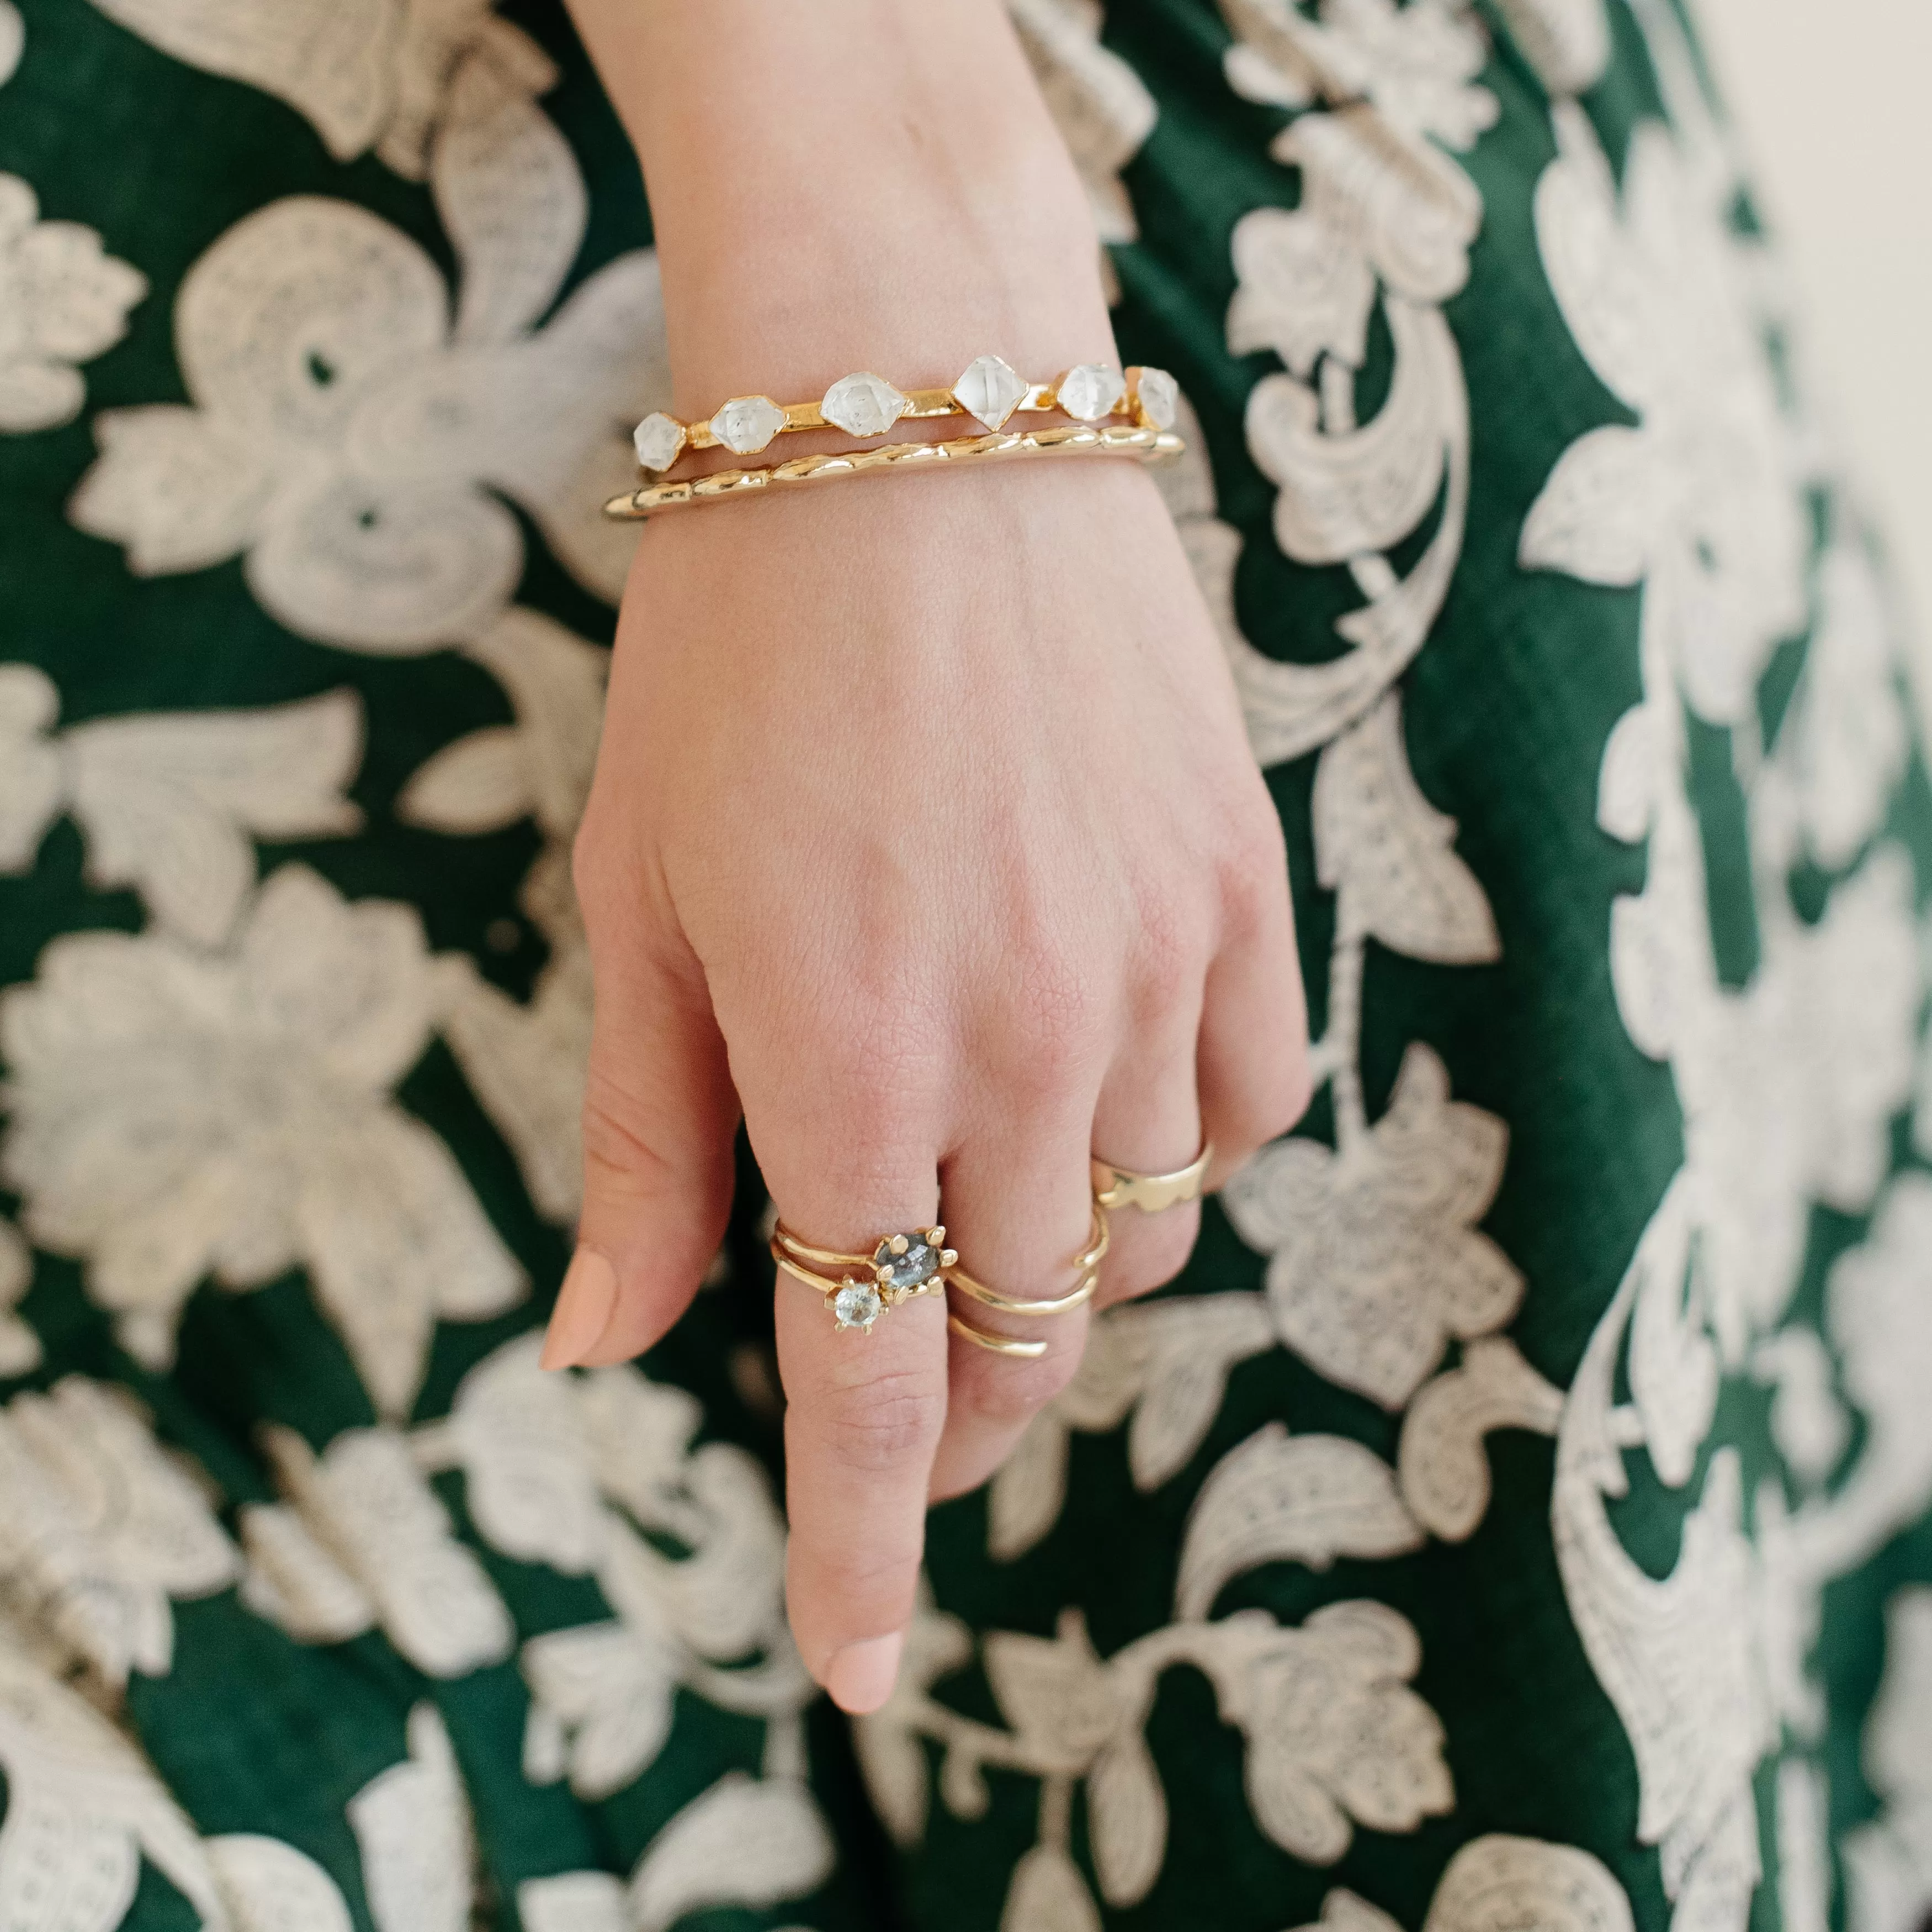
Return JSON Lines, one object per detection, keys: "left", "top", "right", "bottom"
{"left": 0, "top": 174, "right": 147, "bottom": 435}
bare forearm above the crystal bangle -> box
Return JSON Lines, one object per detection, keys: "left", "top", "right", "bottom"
{"left": 572, "top": 0, "right": 1113, "bottom": 413}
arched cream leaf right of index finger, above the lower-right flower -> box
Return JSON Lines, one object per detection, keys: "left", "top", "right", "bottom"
{"left": 1175, "top": 1422, "right": 1422, "bottom": 1617}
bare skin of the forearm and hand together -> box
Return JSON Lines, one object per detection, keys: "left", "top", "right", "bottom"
{"left": 545, "top": 0, "right": 1308, "bottom": 1712}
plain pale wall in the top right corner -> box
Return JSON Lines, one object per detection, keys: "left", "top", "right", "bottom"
{"left": 1692, "top": 0, "right": 1932, "bottom": 721}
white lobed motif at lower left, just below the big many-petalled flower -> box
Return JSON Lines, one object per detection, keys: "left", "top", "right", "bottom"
{"left": 242, "top": 1424, "right": 516, "bottom": 1677}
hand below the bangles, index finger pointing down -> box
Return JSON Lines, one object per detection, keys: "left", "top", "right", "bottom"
{"left": 547, "top": 460, "right": 1308, "bottom": 1710}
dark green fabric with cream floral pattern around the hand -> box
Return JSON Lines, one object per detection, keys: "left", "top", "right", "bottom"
{"left": 0, "top": 0, "right": 1932, "bottom": 1932}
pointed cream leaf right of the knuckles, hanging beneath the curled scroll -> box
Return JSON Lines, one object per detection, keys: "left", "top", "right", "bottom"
{"left": 1314, "top": 692, "right": 1503, "bottom": 966}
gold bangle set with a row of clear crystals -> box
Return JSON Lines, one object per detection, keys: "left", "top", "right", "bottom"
{"left": 632, "top": 355, "right": 1181, "bottom": 475}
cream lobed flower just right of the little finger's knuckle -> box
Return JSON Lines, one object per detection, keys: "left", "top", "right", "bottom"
{"left": 1223, "top": 1043, "right": 1522, "bottom": 1409}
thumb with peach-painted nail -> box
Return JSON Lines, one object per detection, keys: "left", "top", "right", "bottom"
{"left": 543, "top": 930, "right": 738, "bottom": 1368}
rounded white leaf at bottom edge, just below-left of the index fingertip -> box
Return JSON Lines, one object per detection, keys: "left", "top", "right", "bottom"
{"left": 630, "top": 1772, "right": 837, "bottom": 1932}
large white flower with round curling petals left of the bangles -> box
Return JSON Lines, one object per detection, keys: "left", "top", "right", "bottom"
{"left": 72, "top": 128, "right": 668, "bottom": 653}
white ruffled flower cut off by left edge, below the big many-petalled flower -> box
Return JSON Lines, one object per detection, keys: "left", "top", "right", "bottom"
{"left": 0, "top": 1376, "right": 238, "bottom": 1692}
